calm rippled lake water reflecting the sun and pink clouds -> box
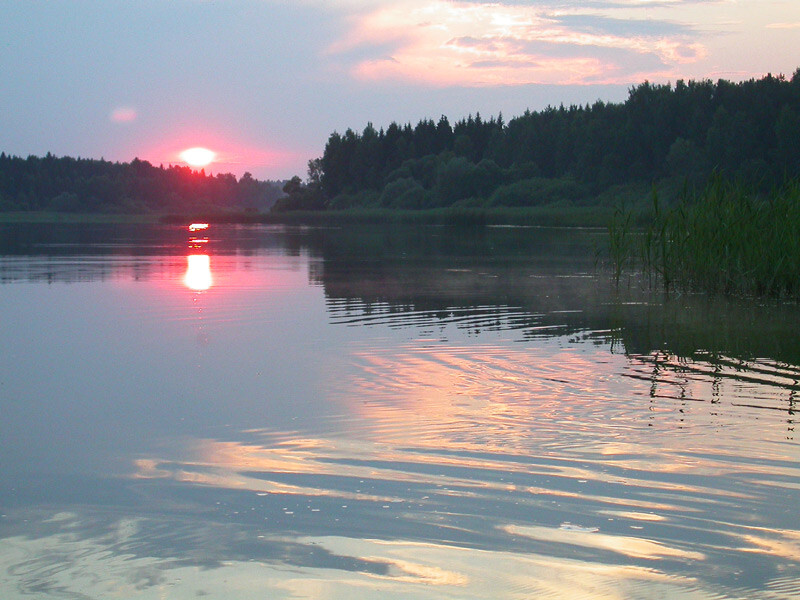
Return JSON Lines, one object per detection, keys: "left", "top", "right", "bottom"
{"left": 0, "top": 225, "right": 800, "bottom": 599}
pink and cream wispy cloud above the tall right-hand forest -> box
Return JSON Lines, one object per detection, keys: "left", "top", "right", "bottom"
{"left": 329, "top": 0, "right": 706, "bottom": 86}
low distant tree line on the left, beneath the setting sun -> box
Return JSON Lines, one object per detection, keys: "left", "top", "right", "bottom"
{"left": 0, "top": 152, "right": 283, "bottom": 214}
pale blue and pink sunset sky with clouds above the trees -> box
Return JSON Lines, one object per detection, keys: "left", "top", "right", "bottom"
{"left": 0, "top": 0, "right": 800, "bottom": 179}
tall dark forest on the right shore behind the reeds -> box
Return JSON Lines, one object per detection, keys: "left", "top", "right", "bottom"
{"left": 273, "top": 69, "right": 800, "bottom": 211}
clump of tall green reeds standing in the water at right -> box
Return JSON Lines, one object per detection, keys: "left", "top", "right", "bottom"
{"left": 609, "top": 177, "right": 800, "bottom": 298}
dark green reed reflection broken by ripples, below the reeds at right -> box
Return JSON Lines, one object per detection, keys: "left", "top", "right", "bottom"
{"left": 610, "top": 295, "right": 800, "bottom": 439}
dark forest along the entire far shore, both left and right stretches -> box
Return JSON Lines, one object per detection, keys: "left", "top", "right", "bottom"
{"left": 0, "top": 69, "right": 800, "bottom": 217}
